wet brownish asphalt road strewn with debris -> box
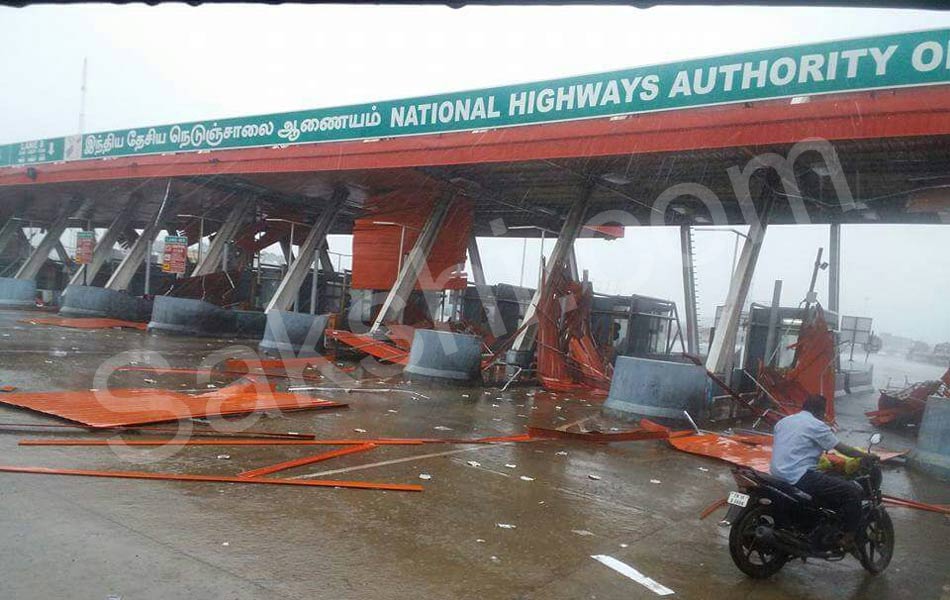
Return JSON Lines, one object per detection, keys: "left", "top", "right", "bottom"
{"left": 0, "top": 311, "right": 950, "bottom": 600}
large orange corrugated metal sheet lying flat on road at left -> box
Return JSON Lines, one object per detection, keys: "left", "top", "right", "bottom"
{"left": 0, "top": 382, "right": 346, "bottom": 427}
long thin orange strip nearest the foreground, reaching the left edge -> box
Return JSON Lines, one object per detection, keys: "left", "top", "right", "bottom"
{"left": 0, "top": 466, "right": 422, "bottom": 492}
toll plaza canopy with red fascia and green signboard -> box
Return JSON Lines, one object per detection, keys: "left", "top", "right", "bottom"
{"left": 0, "top": 30, "right": 950, "bottom": 236}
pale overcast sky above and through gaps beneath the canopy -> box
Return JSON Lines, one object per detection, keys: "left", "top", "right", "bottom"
{"left": 0, "top": 5, "right": 950, "bottom": 343}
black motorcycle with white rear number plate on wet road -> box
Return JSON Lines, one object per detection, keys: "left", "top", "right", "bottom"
{"left": 724, "top": 433, "right": 894, "bottom": 579}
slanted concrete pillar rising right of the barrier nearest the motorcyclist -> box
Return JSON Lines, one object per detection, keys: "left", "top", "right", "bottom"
{"left": 706, "top": 192, "right": 773, "bottom": 374}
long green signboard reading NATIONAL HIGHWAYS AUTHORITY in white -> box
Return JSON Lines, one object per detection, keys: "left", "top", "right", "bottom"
{"left": 0, "top": 29, "right": 950, "bottom": 166}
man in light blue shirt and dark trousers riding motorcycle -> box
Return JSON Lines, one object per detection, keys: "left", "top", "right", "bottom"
{"left": 770, "top": 395, "right": 876, "bottom": 549}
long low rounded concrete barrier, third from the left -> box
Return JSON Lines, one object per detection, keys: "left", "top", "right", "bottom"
{"left": 148, "top": 296, "right": 266, "bottom": 338}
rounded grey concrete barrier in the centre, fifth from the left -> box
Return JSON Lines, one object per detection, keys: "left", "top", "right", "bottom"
{"left": 405, "top": 329, "right": 482, "bottom": 383}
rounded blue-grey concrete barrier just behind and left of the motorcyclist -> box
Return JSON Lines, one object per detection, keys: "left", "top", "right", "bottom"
{"left": 604, "top": 356, "right": 709, "bottom": 421}
